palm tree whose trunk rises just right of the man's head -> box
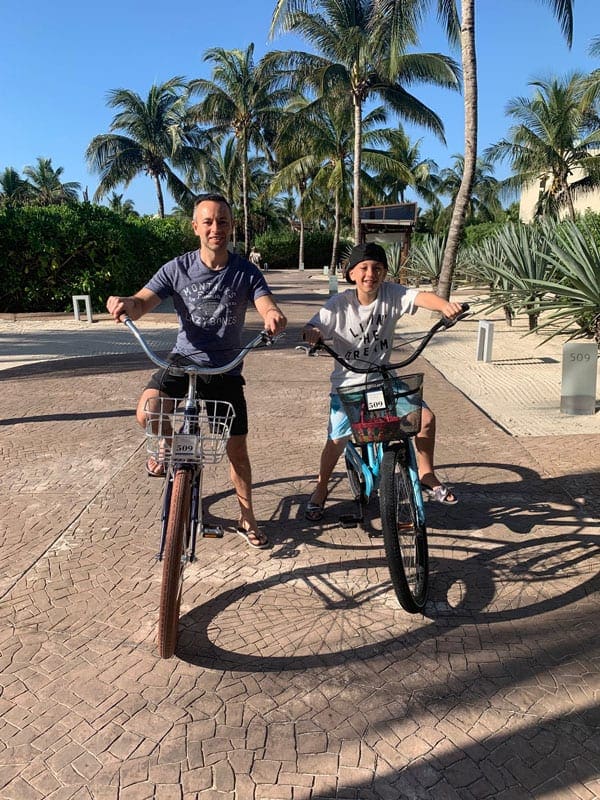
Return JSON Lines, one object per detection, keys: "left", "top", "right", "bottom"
{"left": 189, "top": 44, "right": 288, "bottom": 252}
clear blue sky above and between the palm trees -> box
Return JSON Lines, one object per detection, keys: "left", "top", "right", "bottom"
{"left": 0, "top": 0, "right": 600, "bottom": 213}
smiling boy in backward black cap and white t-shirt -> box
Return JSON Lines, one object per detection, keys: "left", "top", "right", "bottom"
{"left": 303, "top": 242, "right": 462, "bottom": 522}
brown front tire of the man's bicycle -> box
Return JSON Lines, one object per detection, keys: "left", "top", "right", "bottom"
{"left": 157, "top": 469, "right": 192, "bottom": 658}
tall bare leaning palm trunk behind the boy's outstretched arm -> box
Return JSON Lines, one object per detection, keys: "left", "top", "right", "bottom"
{"left": 437, "top": 0, "right": 477, "bottom": 300}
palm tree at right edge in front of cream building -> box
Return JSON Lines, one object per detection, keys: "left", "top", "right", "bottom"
{"left": 486, "top": 73, "right": 600, "bottom": 219}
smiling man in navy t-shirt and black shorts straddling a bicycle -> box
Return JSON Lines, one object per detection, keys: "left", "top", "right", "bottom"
{"left": 106, "top": 194, "right": 287, "bottom": 548}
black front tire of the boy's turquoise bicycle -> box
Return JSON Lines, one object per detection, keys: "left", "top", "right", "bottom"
{"left": 380, "top": 444, "right": 429, "bottom": 614}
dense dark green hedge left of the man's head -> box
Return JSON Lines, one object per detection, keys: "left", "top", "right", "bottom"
{"left": 0, "top": 203, "right": 197, "bottom": 313}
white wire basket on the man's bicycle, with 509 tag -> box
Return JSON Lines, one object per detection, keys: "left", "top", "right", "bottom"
{"left": 145, "top": 397, "right": 235, "bottom": 465}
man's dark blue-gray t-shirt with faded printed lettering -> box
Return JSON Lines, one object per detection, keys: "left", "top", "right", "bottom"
{"left": 144, "top": 250, "right": 271, "bottom": 375}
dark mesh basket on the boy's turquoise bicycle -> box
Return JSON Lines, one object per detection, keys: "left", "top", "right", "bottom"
{"left": 337, "top": 373, "right": 423, "bottom": 444}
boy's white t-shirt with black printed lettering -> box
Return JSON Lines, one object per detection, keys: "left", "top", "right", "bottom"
{"left": 309, "top": 281, "right": 419, "bottom": 392}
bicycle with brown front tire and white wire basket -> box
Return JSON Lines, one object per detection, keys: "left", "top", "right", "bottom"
{"left": 121, "top": 316, "right": 283, "bottom": 658}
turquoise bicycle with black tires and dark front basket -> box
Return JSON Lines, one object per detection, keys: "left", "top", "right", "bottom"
{"left": 300, "top": 303, "right": 469, "bottom": 614}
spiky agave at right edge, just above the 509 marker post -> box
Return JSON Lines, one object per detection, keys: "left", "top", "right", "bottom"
{"left": 531, "top": 220, "right": 600, "bottom": 345}
